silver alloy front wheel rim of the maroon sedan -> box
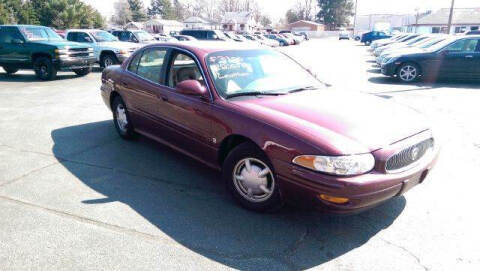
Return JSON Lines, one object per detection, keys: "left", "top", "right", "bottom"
{"left": 233, "top": 158, "right": 275, "bottom": 203}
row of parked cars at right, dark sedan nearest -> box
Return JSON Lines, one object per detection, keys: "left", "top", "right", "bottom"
{"left": 364, "top": 33, "right": 480, "bottom": 82}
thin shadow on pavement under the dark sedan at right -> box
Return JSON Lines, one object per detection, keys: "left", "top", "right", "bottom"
{"left": 368, "top": 76, "right": 480, "bottom": 92}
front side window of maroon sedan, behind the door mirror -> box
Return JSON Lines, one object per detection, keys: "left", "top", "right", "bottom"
{"left": 168, "top": 53, "right": 205, "bottom": 88}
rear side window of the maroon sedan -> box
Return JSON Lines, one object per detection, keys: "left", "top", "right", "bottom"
{"left": 137, "top": 49, "right": 167, "bottom": 83}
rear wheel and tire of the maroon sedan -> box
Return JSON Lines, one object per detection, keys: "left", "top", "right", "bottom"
{"left": 112, "top": 96, "right": 137, "bottom": 140}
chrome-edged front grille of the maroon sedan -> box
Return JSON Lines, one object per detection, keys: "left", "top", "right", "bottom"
{"left": 385, "top": 138, "right": 434, "bottom": 172}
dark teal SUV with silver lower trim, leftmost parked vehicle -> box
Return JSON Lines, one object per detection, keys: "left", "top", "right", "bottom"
{"left": 0, "top": 25, "right": 95, "bottom": 80}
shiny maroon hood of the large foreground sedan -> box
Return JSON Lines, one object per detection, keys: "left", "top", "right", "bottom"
{"left": 233, "top": 88, "right": 429, "bottom": 155}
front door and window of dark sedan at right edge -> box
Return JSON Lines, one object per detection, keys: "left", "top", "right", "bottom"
{"left": 440, "top": 38, "right": 479, "bottom": 78}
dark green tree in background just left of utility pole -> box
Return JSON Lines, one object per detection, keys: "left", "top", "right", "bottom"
{"left": 317, "top": 0, "right": 354, "bottom": 30}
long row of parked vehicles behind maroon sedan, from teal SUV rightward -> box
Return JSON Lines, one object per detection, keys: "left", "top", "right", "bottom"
{"left": 0, "top": 25, "right": 308, "bottom": 80}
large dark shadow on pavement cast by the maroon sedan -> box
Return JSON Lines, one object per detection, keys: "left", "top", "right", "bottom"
{"left": 51, "top": 121, "right": 406, "bottom": 269}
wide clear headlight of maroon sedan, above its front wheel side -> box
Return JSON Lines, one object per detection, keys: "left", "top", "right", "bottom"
{"left": 293, "top": 153, "right": 375, "bottom": 176}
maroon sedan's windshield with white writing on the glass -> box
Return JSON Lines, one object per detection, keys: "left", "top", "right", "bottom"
{"left": 207, "top": 50, "right": 323, "bottom": 98}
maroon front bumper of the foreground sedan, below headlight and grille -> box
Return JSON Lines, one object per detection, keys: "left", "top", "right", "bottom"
{"left": 275, "top": 132, "right": 439, "bottom": 214}
